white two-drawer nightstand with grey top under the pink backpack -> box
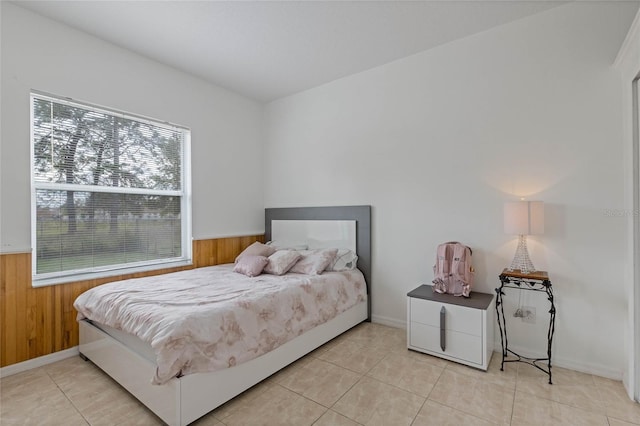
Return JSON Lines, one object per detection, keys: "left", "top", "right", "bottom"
{"left": 407, "top": 285, "right": 495, "bottom": 370}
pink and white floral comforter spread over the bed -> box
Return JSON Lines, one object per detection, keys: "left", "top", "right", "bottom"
{"left": 74, "top": 265, "right": 367, "bottom": 384}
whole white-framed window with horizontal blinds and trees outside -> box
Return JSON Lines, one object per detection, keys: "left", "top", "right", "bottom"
{"left": 31, "top": 93, "right": 191, "bottom": 286}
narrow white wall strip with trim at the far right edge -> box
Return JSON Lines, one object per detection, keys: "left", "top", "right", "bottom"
{"left": 615, "top": 8, "right": 640, "bottom": 401}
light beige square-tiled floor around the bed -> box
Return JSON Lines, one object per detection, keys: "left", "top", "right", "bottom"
{"left": 0, "top": 323, "right": 640, "bottom": 426}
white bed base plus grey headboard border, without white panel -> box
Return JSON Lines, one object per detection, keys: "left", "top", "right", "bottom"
{"left": 80, "top": 206, "right": 371, "bottom": 425}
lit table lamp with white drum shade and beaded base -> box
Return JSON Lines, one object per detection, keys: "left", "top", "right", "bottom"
{"left": 504, "top": 201, "right": 544, "bottom": 274}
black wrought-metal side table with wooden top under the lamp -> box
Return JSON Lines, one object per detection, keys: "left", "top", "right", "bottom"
{"left": 496, "top": 269, "right": 556, "bottom": 384}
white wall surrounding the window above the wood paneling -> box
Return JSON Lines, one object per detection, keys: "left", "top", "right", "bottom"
{"left": 0, "top": 2, "right": 264, "bottom": 252}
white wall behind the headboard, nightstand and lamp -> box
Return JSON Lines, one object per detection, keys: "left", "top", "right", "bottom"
{"left": 265, "top": 2, "right": 637, "bottom": 378}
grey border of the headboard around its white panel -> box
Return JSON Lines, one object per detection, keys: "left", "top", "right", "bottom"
{"left": 264, "top": 206, "right": 371, "bottom": 321}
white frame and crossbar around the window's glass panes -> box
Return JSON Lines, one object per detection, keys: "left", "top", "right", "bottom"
{"left": 29, "top": 90, "right": 193, "bottom": 287}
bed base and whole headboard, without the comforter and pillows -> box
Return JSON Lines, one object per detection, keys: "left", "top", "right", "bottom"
{"left": 80, "top": 206, "right": 371, "bottom": 425}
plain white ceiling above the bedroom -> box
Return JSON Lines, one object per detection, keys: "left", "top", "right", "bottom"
{"left": 15, "top": 0, "right": 564, "bottom": 101}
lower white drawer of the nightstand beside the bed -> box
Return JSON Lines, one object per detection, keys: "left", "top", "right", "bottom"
{"left": 409, "top": 322, "right": 483, "bottom": 365}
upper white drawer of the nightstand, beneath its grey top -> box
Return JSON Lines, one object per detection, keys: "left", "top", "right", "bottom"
{"left": 409, "top": 298, "right": 482, "bottom": 341}
